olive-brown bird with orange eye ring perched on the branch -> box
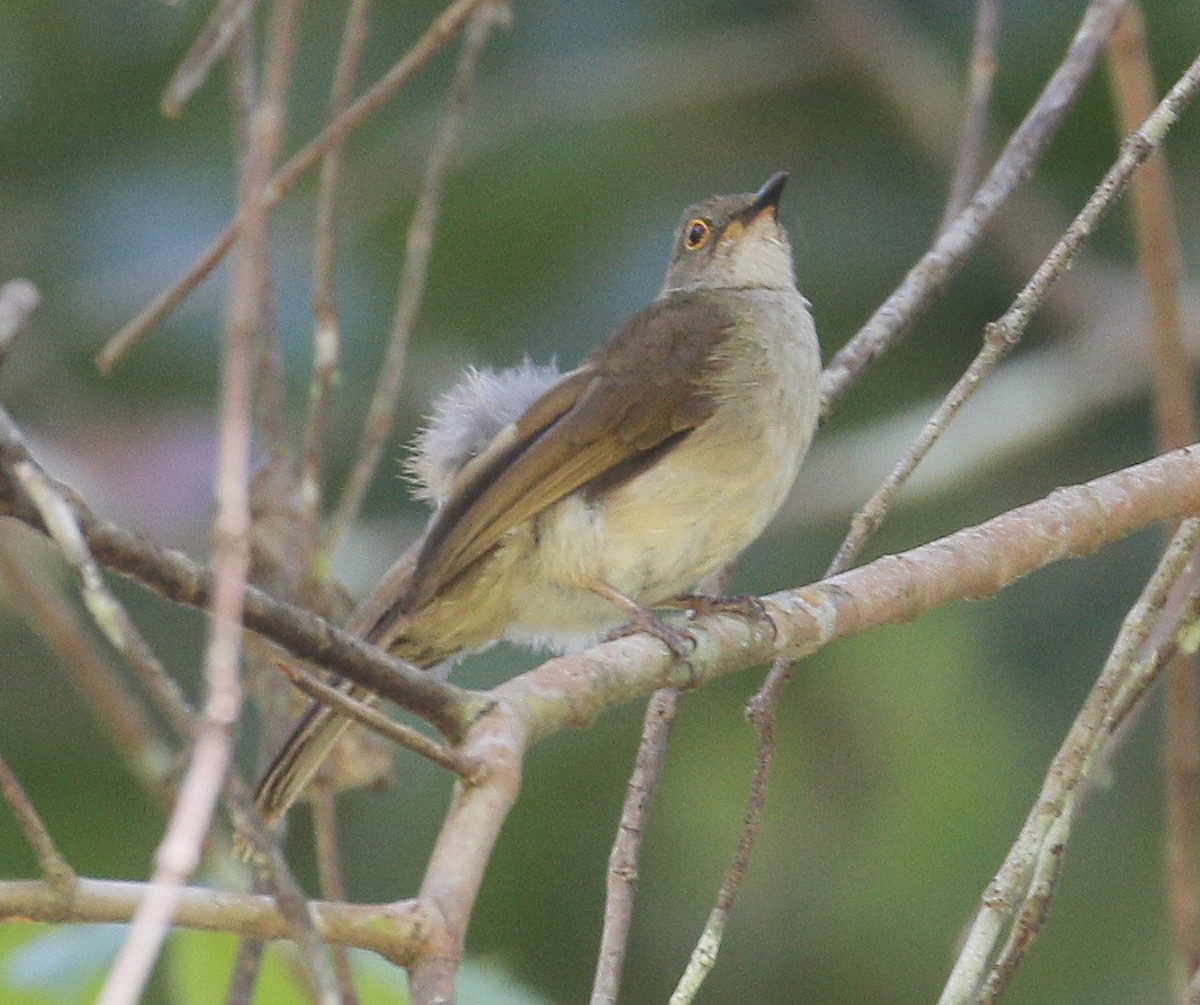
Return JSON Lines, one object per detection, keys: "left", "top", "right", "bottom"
{"left": 250, "top": 173, "right": 821, "bottom": 822}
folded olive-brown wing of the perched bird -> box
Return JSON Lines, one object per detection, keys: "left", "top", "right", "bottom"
{"left": 404, "top": 293, "right": 733, "bottom": 610}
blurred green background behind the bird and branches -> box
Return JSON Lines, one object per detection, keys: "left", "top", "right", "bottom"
{"left": 0, "top": 0, "right": 1200, "bottom": 1005}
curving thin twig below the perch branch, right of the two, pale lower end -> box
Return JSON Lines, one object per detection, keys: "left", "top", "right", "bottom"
{"left": 670, "top": 658, "right": 792, "bottom": 1005}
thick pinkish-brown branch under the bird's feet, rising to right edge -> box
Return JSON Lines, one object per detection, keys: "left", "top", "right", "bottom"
{"left": 501, "top": 445, "right": 1200, "bottom": 753}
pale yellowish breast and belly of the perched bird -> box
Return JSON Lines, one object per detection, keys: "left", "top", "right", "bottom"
{"left": 517, "top": 290, "right": 820, "bottom": 634}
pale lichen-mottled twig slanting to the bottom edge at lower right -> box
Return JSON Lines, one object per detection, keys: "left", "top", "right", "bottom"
{"left": 938, "top": 518, "right": 1200, "bottom": 1005}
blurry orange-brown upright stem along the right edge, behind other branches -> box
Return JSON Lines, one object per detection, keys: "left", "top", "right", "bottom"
{"left": 1109, "top": 4, "right": 1200, "bottom": 993}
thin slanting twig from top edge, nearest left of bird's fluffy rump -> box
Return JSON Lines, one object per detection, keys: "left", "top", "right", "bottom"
{"left": 318, "top": 2, "right": 508, "bottom": 565}
